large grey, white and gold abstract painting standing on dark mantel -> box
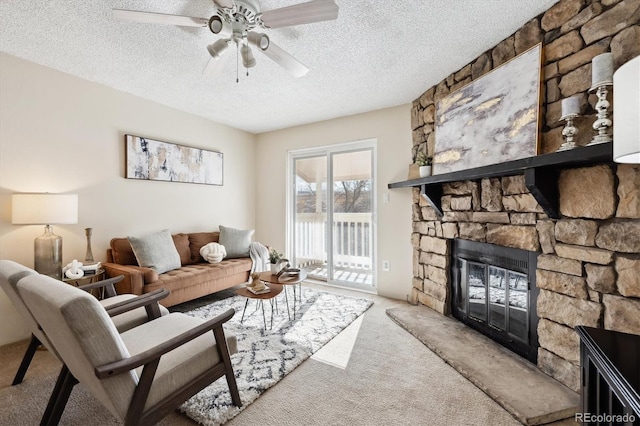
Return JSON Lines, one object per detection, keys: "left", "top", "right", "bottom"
{"left": 433, "top": 44, "right": 542, "bottom": 174}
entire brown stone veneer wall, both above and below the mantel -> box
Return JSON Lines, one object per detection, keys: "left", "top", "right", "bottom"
{"left": 411, "top": 0, "right": 640, "bottom": 390}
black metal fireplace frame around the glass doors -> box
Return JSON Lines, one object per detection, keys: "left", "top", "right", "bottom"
{"left": 450, "top": 239, "right": 540, "bottom": 364}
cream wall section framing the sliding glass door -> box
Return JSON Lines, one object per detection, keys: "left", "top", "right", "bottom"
{"left": 256, "top": 105, "right": 413, "bottom": 299}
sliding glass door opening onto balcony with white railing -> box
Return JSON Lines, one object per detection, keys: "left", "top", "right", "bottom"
{"left": 288, "top": 141, "right": 375, "bottom": 290}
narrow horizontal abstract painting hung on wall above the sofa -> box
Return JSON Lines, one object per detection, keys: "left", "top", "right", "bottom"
{"left": 125, "top": 135, "right": 223, "bottom": 185}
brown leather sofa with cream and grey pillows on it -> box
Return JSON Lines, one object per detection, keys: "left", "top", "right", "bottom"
{"left": 102, "top": 232, "right": 252, "bottom": 307}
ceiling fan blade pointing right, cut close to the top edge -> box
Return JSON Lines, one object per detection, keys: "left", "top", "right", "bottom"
{"left": 262, "top": 0, "right": 338, "bottom": 28}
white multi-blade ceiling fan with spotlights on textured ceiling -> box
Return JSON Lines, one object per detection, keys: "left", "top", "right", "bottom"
{"left": 113, "top": 0, "right": 338, "bottom": 81}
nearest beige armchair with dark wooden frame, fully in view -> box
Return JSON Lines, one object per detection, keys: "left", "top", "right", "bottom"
{"left": 18, "top": 264, "right": 242, "bottom": 425}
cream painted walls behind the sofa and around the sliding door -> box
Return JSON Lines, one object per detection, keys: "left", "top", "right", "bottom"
{"left": 0, "top": 53, "right": 412, "bottom": 345}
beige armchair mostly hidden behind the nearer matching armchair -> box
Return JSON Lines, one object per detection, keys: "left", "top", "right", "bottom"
{"left": 0, "top": 260, "right": 169, "bottom": 385}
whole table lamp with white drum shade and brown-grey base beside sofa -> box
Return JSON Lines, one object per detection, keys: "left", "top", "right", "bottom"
{"left": 11, "top": 193, "right": 78, "bottom": 279}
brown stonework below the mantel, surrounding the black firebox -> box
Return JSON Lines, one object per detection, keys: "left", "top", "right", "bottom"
{"left": 411, "top": 165, "right": 640, "bottom": 390}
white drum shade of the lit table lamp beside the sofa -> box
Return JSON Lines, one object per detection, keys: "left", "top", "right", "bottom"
{"left": 11, "top": 194, "right": 78, "bottom": 225}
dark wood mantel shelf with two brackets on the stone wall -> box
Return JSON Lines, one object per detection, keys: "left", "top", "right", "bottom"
{"left": 388, "top": 143, "right": 613, "bottom": 219}
